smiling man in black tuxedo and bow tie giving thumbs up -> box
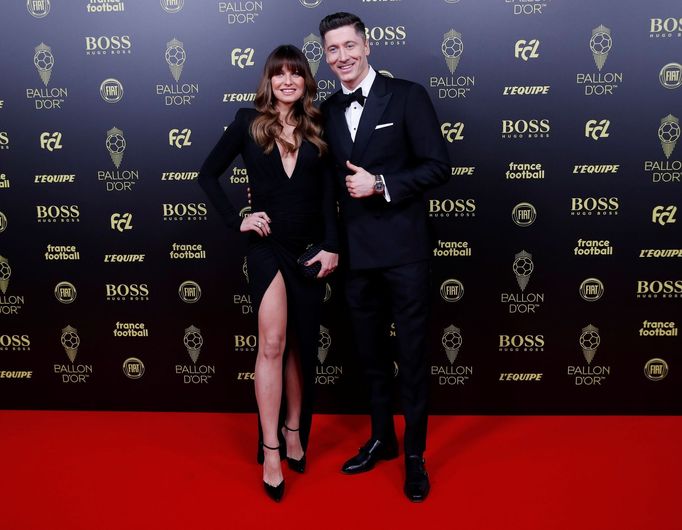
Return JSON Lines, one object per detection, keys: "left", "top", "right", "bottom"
{"left": 320, "top": 13, "right": 450, "bottom": 501}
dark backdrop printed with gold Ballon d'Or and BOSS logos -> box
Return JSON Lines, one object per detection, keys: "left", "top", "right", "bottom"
{"left": 0, "top": 0, "right": 682, "bottom": 414}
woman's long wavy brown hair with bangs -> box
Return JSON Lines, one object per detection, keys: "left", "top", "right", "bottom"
{"left": 251, "top": 44, "right": 327, "bottom": 156}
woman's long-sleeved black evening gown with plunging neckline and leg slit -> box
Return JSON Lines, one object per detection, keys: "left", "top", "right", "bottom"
{"left": 198, "top": 109, "right": 338, "bottom": 454}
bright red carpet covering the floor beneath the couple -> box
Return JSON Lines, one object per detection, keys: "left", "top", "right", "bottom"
{"left": 0, "top": 411, "right": 682, "bottom": 530}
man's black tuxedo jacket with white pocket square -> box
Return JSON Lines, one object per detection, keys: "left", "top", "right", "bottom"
{"left": 322, "top": 74, "right": 450, "bottom": 269}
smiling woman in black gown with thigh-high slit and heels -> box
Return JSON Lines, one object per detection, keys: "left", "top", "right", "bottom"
{"left": 198, "top": 45, "right": 338, "bottom": 501}
